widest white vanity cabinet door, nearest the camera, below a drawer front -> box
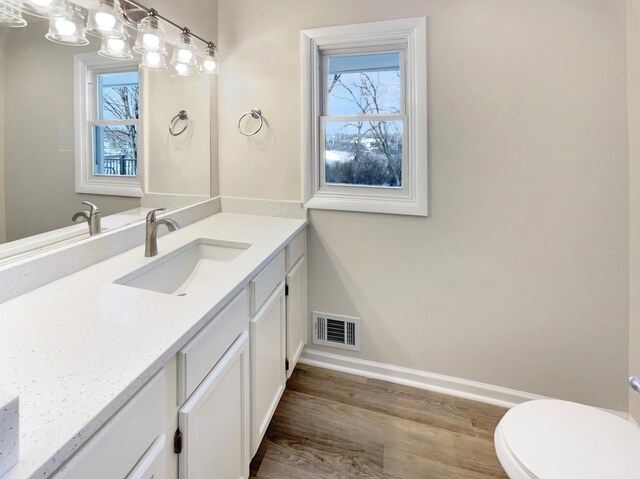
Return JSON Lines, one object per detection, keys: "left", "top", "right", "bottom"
{"left": 178, "top": 331, "right": 251, "bottom": 479}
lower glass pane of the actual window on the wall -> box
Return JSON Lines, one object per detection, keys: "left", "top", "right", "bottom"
{"left": 324, "top": 121, "right": 403, "bottom": 188}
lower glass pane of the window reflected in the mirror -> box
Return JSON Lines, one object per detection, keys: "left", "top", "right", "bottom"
{"left": 93, "top": 125, "right": 138, "bottom": 176}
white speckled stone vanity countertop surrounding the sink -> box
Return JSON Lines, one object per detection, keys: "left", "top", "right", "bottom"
{"left": 0, "top": 213, "right": 306, "bottom": 479}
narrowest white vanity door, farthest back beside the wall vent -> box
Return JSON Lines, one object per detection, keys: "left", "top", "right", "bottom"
{"left": 287, "top": 256, "right": 307, "bottom": 379}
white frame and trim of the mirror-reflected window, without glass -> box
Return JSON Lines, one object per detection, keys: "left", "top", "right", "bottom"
{"left": 73, "top": 53, "right": 144, "bottom": 198}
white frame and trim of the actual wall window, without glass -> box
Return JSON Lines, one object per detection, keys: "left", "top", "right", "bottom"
{"left": 301, "top": 17, "right": 428, "bottom": 216}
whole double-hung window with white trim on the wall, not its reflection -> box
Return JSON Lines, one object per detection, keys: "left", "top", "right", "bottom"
{"left": 302, "top": 18, "right": 427, "bottom": 216}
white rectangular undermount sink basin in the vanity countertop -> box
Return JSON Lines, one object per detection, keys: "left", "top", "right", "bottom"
{"left": 114, "top": 238, "right": 251, "bottom": 296}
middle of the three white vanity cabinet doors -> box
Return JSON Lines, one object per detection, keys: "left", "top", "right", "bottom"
{"left": 249, "top": 282, "right": 286, "bottom": 456}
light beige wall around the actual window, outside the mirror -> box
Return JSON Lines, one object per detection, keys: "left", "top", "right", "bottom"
{"left": 219, "top": 0, "right": 629, "bottom": 410}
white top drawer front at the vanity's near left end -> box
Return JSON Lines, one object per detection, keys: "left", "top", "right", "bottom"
{"left": 53, "top": 371, "right": 165, "bottom": 479}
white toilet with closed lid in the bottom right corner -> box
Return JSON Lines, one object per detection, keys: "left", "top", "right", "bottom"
{"left": 494, "top": 399, "right": 640, "bottom": 479}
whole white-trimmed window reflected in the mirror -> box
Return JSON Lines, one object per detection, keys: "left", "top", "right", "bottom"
{"left": 74, "top": 53, "right": 143, "bottom": 197}
